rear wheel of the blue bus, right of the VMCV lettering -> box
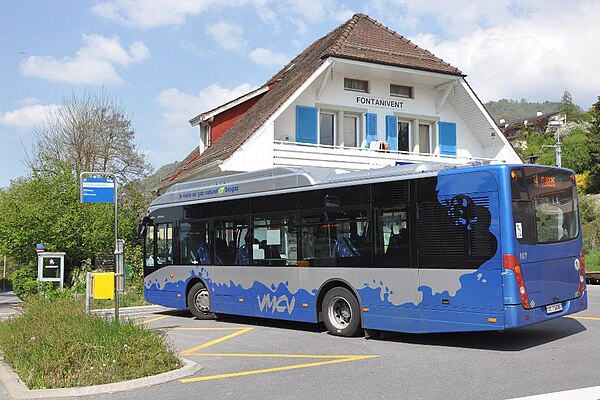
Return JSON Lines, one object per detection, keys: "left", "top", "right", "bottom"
{"left": 322, "top": 287, "right": 361, "bottom": 336}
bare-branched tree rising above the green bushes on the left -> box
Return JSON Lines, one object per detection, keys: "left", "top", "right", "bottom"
{"left": 29, "top": 91, "right": 151, "bottom": 182}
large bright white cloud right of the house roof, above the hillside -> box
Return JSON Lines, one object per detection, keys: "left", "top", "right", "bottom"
{"left": 415, "top": 2, "right": 600, "bottom": 107}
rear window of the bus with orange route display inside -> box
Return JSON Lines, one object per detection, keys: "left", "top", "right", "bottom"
{"left": 511, "top": 167, "right": 579, "bottom": 244}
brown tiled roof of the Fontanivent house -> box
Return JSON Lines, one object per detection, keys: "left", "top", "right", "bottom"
{"left": 163, "top": 14, "right": 463, "bottom": 186}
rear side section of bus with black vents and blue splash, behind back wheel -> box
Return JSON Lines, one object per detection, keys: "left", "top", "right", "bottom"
{"left": 416, "top": 170, "right": 503, "bottom": 332}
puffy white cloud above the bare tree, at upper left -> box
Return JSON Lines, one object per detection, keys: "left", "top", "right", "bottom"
{"left": 21, "top": 35, "right": 150, "bottom": 85}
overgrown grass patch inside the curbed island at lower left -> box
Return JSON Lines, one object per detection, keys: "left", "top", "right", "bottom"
{"left": 0, "top": 297, "right": 180, "bottom": 389}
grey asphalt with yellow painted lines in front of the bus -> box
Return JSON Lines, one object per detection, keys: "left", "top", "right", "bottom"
{"left": 1, "top": 286, "right": 600, "bottom": 400}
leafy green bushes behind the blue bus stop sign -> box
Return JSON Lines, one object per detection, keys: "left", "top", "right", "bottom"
{"left": 0, "top": 163, "right": 146, "bottom": 276}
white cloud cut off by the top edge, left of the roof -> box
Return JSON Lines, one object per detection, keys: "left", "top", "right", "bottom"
{"left": 92, "top": 0, "right": 219, "bottom": 29}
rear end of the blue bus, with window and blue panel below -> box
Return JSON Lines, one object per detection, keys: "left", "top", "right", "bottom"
{"left": 509, "top": 167, "right": 583, "bottom": 312}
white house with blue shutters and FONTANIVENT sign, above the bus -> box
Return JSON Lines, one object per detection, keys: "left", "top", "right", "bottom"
{"left": 163, "top": 14, "right": 521, "bottom": 191}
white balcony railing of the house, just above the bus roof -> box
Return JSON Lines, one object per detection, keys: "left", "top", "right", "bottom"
{"left": 273, "top": 140, "right": 505, "bottom": 170}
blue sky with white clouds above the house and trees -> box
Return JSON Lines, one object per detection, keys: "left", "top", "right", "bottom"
{"left": 0, "top": 0, "right": 600, "bottom": 186}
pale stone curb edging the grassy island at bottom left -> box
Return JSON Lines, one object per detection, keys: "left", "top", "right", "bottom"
{"left": 0, "top": 357, "right": 202, "bottom": 400}
